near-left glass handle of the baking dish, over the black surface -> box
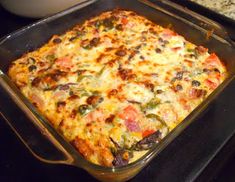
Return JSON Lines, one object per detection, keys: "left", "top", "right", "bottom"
{"left": 0, "top": 70, "right": 73, "bottom": 164}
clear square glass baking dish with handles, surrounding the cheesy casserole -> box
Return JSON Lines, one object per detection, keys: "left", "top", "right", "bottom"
{"left": 0, "top": 0, "right": 235, "bottom": 181}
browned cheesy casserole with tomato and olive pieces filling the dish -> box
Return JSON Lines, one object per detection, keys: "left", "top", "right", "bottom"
{"left": 9, "top": 10, "right": 226, "bottom": 166}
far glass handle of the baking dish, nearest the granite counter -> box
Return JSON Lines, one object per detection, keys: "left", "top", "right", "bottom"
{"left": 139, "top": 0, "right": 235, "bottom": 46}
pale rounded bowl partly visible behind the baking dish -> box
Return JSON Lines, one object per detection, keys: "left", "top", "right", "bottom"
{"left": 0, "top": 0, "right": 85, "bottom": 18}
